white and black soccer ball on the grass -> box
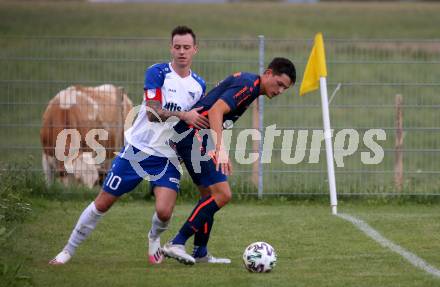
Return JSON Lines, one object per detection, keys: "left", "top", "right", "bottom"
{"left": 243, "top": 242, "right": 277, "bottom": 273}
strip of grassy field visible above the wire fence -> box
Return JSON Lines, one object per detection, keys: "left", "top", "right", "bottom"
{"left": 0, "top": 1, "right": 440, "bottom": 39}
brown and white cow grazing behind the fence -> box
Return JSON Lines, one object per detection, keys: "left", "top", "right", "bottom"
{"left": 40, "top": 84, "right": 132, "bottom": 187}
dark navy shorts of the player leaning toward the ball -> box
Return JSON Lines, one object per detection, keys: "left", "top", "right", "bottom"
{"left": 174, "top": 121, "right": 228, "bottom": 187}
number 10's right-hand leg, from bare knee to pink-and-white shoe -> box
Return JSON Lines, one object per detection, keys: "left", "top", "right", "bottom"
{"left": 148, "top": 186, "right": 177, "bottom": 264}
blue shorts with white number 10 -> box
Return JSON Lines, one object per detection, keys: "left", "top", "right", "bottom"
{"left": 102, "top": 145, "right": 180, "bottom": 196}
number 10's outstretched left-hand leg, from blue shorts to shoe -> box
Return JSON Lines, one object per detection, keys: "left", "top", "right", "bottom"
{"left": 49, "top": 152, "right": 142, "bottom": 265}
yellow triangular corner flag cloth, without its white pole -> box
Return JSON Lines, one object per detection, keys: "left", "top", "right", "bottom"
{"left": 299, "top": 33, "right": 327, "bottom": 96}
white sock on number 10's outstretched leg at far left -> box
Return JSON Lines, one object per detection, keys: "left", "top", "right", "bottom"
{"left": 64, "top": 202, "right": 104, "bottom": 255}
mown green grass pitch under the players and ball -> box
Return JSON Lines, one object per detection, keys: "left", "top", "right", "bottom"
{"left": 1, "top": 200, "right": 440, "bottom": 287}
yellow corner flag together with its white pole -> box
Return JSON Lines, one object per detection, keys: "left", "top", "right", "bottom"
{"left": 299, "top": 33, "right": 338, "bottom": 214}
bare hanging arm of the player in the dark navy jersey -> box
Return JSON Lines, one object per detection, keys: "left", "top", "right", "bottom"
{"left": 208, "top": 99, "right": 232, "bottom": 175}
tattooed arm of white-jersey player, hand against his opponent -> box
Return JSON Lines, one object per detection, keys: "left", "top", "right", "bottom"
{"left": 147, "top": 100, "right": 209, "bottom": 129}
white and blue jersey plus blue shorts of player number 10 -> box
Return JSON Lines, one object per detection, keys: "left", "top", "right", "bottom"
{"left": 102, "top": 63, "right": 206, "bottom": 196}
